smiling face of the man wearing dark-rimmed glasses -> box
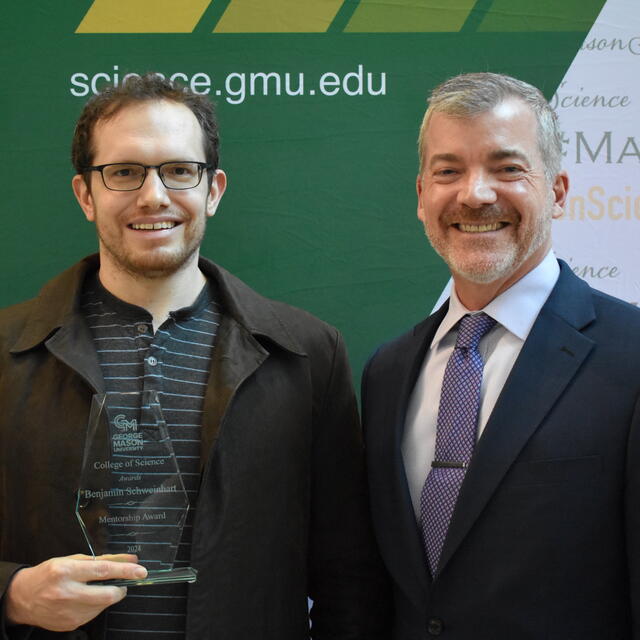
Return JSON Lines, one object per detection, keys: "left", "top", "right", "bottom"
{"left": 73, "top": 100, "right": 226, "bottom": 278}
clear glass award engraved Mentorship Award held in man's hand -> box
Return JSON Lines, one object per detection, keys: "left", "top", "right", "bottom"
{"left": 76, "top": 391, "right": 197, "bottom": 586}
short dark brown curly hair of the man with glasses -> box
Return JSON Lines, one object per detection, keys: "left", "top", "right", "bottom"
{"left": 71, "top": 72, "right": 220, "bottom": 182}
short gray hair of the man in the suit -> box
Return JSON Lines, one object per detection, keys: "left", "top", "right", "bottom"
{"left": 418, "top": 72, "right": 562, "bottom": 180}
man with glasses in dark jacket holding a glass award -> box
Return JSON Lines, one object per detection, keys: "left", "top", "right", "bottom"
{"left": 0, "top": 74, "right": 386, "bottom": 640}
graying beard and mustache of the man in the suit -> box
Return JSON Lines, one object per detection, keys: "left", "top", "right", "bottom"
{"left": 425, "top": 198, "right": 552, "bottom": 284}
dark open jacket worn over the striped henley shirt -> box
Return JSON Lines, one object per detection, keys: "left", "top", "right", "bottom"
{"left": 0, "top": 257, "right": 387, "bottom": 640}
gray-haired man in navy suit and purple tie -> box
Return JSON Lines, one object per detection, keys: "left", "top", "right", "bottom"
{"left": 362, "top": 73, "right": 640, "bottom": 640}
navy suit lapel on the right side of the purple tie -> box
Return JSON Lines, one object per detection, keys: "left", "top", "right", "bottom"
{"left": 440, "top": 263, "right": 595, "bottom": 572}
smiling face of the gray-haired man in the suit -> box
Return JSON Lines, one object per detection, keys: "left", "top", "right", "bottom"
{"left": 417, "top": 98, "right": 567, "bottom": 302}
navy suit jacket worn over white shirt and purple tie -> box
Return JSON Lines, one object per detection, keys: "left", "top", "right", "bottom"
{"left": 362, "top": 262, "right": 640, "bottom": 640}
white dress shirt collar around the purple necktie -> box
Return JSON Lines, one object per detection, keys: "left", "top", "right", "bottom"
{"left": 431, "top": 251, "right": 560, "bottom": 349}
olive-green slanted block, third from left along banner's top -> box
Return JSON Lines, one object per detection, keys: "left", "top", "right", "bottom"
{"left": 345, "top": 0, "right": 475, "bottom": 33}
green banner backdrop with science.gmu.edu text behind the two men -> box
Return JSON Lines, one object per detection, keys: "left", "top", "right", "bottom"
{"left": 0, "top": 0, "right": 604, "bottom": 378}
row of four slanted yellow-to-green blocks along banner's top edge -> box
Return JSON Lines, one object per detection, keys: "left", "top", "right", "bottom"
{"left": 76, "top": 0, "right": 603, "bottom": 34}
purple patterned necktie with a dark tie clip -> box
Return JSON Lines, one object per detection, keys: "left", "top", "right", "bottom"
{"left": 420, "top": 313, "right": 496, "bottom": 577}
